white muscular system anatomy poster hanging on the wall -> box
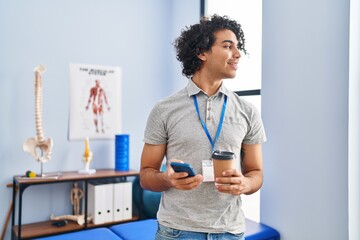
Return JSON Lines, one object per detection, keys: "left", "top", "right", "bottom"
{"left": 69, "top": 64, "right": 121, "bottom": 140}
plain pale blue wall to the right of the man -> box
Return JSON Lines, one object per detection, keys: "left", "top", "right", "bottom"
{"left": 261, "top": 0, "right": 349, "bottom": 240}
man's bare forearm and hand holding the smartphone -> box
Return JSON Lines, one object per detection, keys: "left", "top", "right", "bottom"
{"left": 140, "top": 143, "right": 203, "bottom": 192}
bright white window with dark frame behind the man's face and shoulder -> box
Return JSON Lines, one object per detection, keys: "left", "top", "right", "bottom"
{"left": 201, "top": 0, "right": 262, "bottom": 221}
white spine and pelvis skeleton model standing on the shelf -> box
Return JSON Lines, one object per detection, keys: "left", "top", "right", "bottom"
{"left": 23, "top": 65, "right": 57, "bottom": 177}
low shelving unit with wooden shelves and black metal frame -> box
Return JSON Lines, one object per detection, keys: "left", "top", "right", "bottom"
{"left": 11, "top": 169, "right": 140, "bottom": 239}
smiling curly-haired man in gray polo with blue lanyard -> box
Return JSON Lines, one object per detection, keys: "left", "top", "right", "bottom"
{"left": 140, "top": 15, "right": 265, "bottom": 240}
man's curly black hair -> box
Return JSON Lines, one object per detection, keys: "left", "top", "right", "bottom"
{"left": 173, "top": 14, "right": 247, "bottom": 78}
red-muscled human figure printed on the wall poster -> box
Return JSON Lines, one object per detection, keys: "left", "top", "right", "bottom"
{"left": 85, "top": 80, "right": 110, "bottom": 133}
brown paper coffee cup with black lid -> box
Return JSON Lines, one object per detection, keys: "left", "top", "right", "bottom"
{"left": 211, "top": 150, "right": 235, "bottom": 178}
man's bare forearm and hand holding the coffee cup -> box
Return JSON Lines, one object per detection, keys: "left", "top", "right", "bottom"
{"left": 216, "top": 144, "right": 263, "bottom": 195}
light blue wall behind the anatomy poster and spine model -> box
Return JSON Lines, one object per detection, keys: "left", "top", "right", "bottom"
{"left": 0, "top": 0, "right": 200, "bottom": 239}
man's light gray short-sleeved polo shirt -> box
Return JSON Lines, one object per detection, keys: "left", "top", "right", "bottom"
{"left": 144, "top": 80, "right": 266, "bottom": 233}
